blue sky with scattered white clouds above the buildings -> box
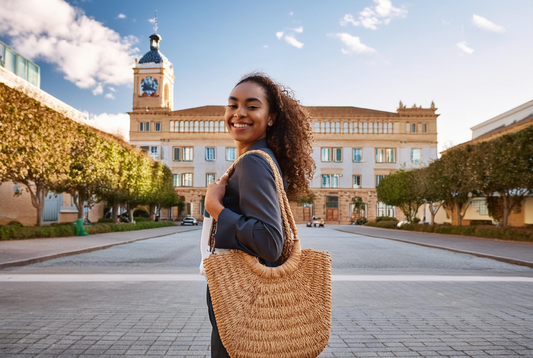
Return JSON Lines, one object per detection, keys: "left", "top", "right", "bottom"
{"left": 0, "top": 0, "right": 533, "bottom": 151}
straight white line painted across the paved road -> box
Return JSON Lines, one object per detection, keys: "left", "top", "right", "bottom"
{"left": 0, "top": 274, "right": 533, "bottom": 282}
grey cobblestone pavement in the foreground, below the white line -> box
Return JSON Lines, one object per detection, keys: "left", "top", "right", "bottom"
{"left": 0, "top": 277, "right": 533, "bottom": 358}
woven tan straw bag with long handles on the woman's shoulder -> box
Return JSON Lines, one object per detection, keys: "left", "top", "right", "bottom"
{"left": 204, "top": 150, "right": 331, "bottom": 358}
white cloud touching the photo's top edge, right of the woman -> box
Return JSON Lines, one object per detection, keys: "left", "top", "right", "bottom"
{"left": 340, "top": 0, "right": 407, "bottom": 30}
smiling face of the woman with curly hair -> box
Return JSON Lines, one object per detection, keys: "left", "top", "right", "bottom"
{"left": 225, "top": 81, "right": 274, "bottom": 145}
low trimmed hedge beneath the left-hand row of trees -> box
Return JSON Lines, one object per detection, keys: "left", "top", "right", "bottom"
{"left": 0, "top": 221, "right": 175, "bottom": 240}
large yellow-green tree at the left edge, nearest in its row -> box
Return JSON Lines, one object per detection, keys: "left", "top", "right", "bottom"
{"left": 0, "top": 83, "right": 75, "bottom": 226}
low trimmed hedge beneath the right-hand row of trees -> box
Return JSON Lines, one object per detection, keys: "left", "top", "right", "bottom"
{"left": 366, "top": 221, "right": 533, "bottom": 241}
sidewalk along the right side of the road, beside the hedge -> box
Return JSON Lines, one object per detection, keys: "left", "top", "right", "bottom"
{"left": 336, "top": 225, "right": 533, "bottom": 267}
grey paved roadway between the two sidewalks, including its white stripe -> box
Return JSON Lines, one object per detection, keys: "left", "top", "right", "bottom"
{"left": 0, "top": 226, "right": 533, "bottom": 358}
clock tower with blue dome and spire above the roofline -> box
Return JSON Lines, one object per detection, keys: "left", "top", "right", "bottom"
{"left": 133, "top": 26, "right": 174, "bottom": 112}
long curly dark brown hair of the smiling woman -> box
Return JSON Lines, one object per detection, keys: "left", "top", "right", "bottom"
{"left": 235, "top": 72, "right": 316, "bottom": 200}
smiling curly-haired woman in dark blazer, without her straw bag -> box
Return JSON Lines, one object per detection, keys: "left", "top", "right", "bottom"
{"left": 205, "top": 73, "right": 315, "bottom": 358}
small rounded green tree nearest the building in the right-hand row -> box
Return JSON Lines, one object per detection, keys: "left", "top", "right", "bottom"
{"left": 377, "top": 169, "right": 424, "bottom": 221}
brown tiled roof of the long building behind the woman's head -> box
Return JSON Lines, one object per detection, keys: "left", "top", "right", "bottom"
{"left": 172, "top": 106, "right": 398, "bottom": 118}
